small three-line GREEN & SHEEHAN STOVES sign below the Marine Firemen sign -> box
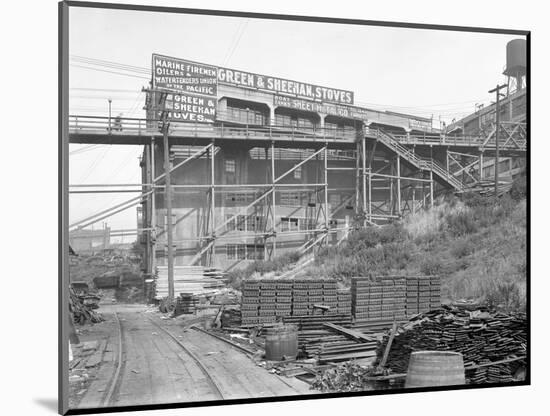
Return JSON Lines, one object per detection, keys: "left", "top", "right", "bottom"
{"left": 158, "top": 94, "right": 217, "bottom": 123}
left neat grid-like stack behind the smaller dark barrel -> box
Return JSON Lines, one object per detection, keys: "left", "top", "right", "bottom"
{"left": 241, "top": 279, "right": 351, "bottom": 326}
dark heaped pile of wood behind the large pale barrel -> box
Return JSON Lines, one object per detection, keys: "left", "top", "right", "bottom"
{"left": 378, "top": 306, "right": 527, "bottom": 382}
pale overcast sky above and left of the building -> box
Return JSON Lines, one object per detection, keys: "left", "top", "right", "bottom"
{"left": 69, "top": 7, "right": 528, "bottom": 237}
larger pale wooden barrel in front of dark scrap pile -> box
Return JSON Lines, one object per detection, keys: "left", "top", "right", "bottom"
{"left": 405, "top": 351, "right": 466, "bottom": 387}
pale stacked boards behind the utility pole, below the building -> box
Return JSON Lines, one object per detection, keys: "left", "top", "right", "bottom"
{"left": 155, "top": 266, "right": 225, "bottom": 300}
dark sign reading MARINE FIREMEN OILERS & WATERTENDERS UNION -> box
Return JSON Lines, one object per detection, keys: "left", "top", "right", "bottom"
{"left": 152, "top": 54, "right": 218, "bottom": 97}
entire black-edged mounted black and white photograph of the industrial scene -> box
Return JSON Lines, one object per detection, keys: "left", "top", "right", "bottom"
{"left": 59, "top": 1, "right": 531, "bottom": 414}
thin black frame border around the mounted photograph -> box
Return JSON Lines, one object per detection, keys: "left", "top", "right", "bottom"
{"left": 58, "top": 0, "right": 532, "bottom": 415}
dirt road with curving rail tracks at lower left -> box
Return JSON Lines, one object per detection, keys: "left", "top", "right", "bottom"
{"left": 73, "top": 305, "right": 313, "bottom": 408}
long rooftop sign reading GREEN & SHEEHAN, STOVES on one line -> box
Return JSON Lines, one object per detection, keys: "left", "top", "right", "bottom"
{"left": 218, "top": 68, "right": 353, "bottom": 104}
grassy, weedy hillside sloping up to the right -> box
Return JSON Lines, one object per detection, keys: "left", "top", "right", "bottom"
{"left": 232, "top": 177, "right": 527, "bottom": 310}
